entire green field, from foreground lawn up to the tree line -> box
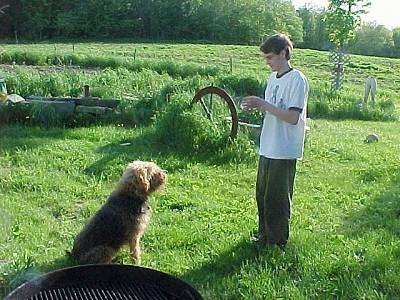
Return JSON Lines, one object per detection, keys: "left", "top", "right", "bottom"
{"left": 0, "top": 43, "right": 400, "bottom": 299}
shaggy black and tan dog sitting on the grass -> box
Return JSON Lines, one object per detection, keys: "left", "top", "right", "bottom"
{"left": 70, "top": 161, "right": 166, "bottom": 264}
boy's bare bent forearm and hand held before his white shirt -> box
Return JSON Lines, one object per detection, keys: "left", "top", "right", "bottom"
{"left": 242, "top": 96, "right": 300, "bottom": 125}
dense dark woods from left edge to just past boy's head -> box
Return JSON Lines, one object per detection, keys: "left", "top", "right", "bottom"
{"left": 0, "top": 0, "right": 302, "bottom": 44}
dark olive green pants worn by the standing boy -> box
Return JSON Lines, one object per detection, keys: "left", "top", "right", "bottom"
{"left": 256, "top": 156, "right": 296, "bottom": 247}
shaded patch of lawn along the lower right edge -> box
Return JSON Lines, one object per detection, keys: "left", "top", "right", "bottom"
{"left": 330, "top": 167, "right": 400, "bottom": 299}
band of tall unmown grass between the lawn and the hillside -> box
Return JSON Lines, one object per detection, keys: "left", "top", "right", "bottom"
{"left": 0, "top": 67, "right": 398, "bottom": 126}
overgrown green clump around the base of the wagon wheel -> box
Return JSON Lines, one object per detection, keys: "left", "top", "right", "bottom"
{"left": 150, "top": 96, "right": 256, "bottom": 163}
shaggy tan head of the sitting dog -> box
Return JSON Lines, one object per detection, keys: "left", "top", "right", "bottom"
{"left": 119, "top": 160, "right": 167, "bottom": 197}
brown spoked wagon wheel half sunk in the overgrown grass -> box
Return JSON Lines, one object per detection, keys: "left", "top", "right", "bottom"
{"left": 192, "top": 86, "right": 239, "bottom": 140}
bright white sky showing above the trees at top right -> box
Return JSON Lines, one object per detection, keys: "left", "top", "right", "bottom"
{"left": 292, "top": 0, "right": 400, "bottom": 29}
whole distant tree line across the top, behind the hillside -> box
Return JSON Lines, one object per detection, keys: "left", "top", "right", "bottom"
{"left": 0, "top": 0, "right": 400, "bottom": 57}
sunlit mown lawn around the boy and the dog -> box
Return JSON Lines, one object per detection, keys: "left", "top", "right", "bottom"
{"left": 0, "top": 120, "right": 400, "bottom": 299}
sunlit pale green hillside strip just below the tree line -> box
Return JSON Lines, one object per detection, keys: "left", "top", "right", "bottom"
{"left": 0, "top": 43, "right": 400, "bottom": 93}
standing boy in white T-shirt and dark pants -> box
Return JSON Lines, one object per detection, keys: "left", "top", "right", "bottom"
{"left": 242, "top": 34, "right": 308, "bottom": 249}
